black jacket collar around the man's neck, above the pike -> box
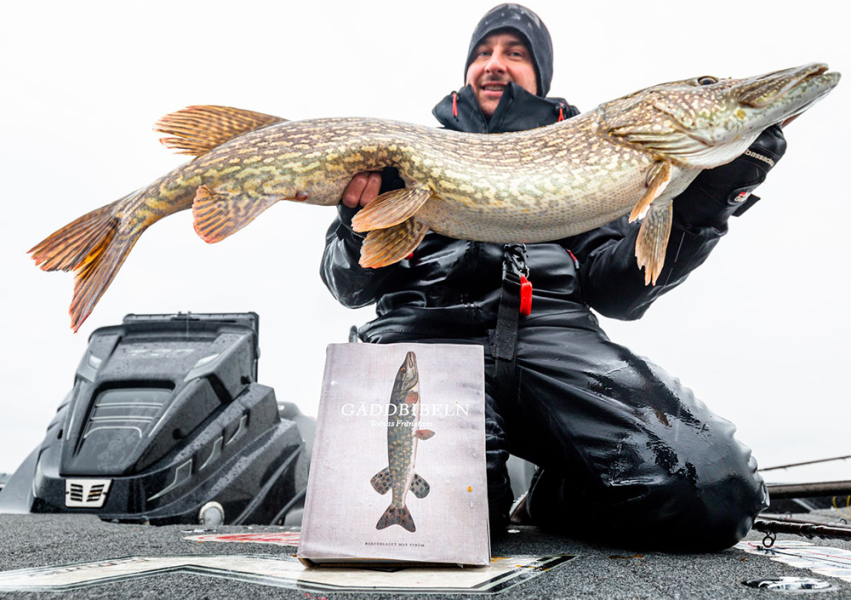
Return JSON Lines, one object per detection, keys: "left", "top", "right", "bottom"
{"left": 431, "top": 83, "right": 579, "bottom": 133}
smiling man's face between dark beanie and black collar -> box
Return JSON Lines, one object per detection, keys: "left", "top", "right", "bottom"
{"left": 467, "top": 32, "right": 538, "bottom": 118}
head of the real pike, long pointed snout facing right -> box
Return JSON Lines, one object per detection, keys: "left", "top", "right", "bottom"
{"left": 599, "top": 63, "right": 840, "bottom": 169}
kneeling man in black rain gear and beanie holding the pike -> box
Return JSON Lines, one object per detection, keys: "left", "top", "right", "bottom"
{"left": 321, "top": 4, "right": 786, "bottom": 551}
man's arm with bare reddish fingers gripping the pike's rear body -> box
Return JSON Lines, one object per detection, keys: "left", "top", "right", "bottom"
{"left": 319, "top": 169, "right": 405, "bottom": 308}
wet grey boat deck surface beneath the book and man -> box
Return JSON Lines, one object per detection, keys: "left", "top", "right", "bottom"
{"left": 0, "top": 510, "right": 851, "bottom": 600}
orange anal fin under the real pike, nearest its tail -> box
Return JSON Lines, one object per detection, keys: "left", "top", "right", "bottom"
{"left": 192, "top": 185, "right": 306, "bottom": 244}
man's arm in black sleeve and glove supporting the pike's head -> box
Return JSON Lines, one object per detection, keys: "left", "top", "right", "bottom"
{"left": 569, "top": 125, "right": 786, "bottom": 320}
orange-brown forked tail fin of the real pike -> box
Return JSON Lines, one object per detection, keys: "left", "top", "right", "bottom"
{"left": 30, "top": 192, "right": 144, "bottom": 332}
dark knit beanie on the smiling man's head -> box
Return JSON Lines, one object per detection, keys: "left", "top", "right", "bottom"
{"left": 464, "top": 4, "right": 553, "bottom": 97}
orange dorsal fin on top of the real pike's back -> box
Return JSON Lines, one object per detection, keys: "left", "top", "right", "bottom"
{"left": 154, "top": 106, "right": 286, "bottom": 156}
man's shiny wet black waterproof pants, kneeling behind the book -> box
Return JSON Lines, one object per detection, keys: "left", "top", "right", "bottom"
{"left": 396, "top": 311, "right": 767, "bottom": 551}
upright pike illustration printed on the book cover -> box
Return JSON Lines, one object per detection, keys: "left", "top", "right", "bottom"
{"left": 370, "top": 352, "right": 434, "bottom": 532}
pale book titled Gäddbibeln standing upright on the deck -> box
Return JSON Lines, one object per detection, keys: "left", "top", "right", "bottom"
{"left": 298, "top": 344, "right": 490, "bottom": 565}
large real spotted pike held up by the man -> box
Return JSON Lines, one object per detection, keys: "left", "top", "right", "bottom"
{"left": 30, "top": 64, "right": 840, "bottom": 331}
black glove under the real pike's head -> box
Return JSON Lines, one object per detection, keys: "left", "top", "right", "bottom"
{"left": 674, "top": 125, "right": 786, "bottom": 229}
